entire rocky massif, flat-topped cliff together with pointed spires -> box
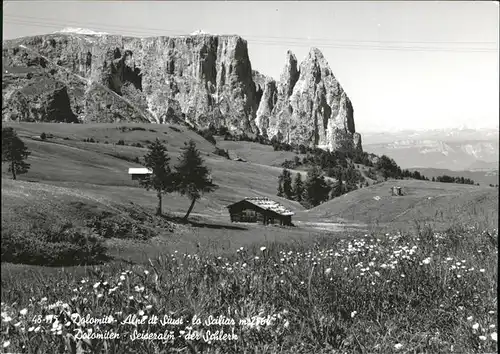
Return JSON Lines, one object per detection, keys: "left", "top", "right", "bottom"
{"left": 2, "top": 29, "right": 361, "bottom": 149}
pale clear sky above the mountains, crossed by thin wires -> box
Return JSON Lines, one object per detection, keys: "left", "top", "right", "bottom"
{"left": 3, "top": 1, "right": 500, "bottom": 133}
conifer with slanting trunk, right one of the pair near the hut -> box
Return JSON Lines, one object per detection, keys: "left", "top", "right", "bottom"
{"left": 175, "top": 140, "right": 216, "bottom": 220}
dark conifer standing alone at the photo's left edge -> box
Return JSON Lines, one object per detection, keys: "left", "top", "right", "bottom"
{"left": 2, "top": 127, "right": 31, "bottom": 179}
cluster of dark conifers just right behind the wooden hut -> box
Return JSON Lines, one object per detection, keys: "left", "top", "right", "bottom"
{"left": 277, "top": 166, "right": 357, "bottom": 208}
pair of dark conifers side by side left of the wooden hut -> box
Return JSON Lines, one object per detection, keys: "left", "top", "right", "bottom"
{"left": 140, "top": 139, "right": 217, "bottom": 220}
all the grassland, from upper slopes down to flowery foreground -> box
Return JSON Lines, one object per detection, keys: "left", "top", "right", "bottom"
{"left": 0, "top": 123, "right": 498, "bottom": 353}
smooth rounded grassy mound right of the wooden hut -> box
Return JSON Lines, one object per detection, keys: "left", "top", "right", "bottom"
{"left": 296, "top": 180, "right": 498, "bottom": 228}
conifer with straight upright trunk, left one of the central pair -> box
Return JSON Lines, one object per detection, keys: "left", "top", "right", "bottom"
{"left": 140, "top": 138, "right": 175, "bottom": 215}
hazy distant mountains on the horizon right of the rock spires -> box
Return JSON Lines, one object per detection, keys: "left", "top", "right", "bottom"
{"left": 363, "top": 129, "right": 499, "bottom": 171}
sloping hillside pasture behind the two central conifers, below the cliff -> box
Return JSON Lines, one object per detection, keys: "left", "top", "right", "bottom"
{"left": 3, "top": 124, "right": 303, "bottom": 214}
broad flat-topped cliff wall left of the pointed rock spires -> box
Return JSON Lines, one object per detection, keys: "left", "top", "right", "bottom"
{"left": 3, "top": 34, "right": 257, "bottom": 131}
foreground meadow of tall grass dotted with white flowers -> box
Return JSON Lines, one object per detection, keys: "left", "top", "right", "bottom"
{"left": 0, "top": 226, "right": 498, "bottom": 353}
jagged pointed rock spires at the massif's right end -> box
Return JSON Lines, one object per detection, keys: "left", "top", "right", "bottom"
{"left": 256, "top": 48, "right": 361, "bottom": 150}
